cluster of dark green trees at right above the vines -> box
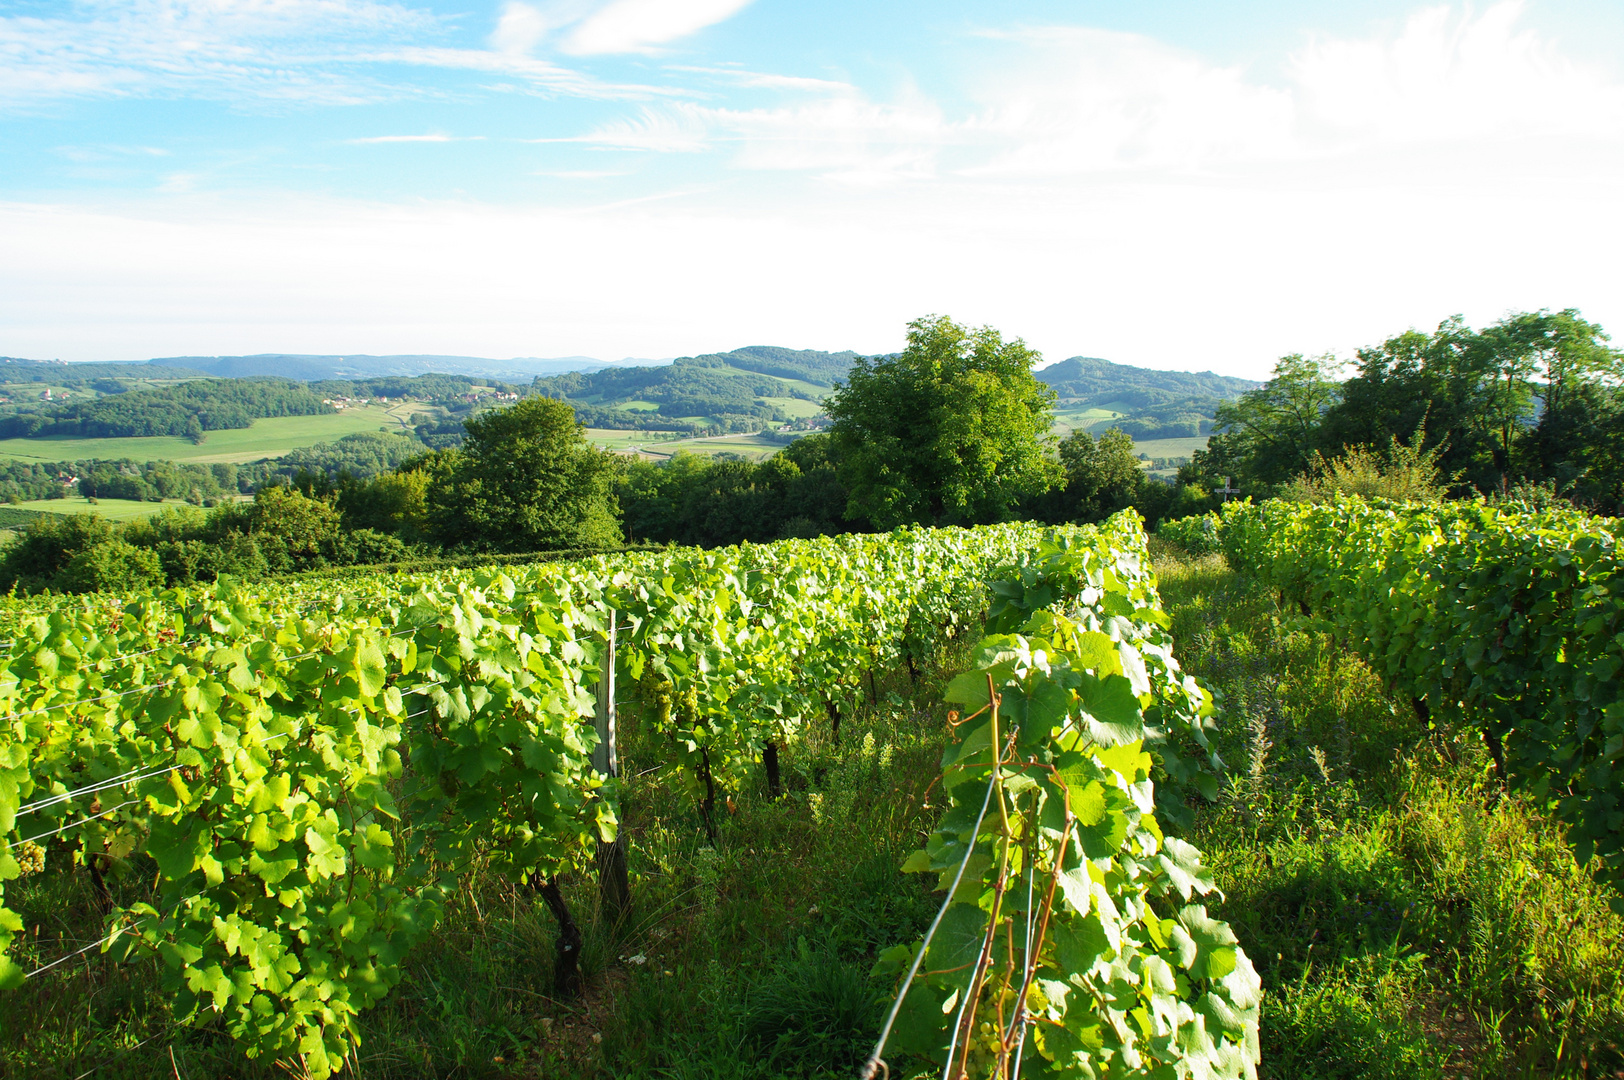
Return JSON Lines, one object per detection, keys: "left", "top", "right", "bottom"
{"left": 1181, "top": 309, "right": 1624, "bottom": 513}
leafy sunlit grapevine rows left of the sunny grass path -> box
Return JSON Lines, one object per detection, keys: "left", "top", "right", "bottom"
{"left": 0, "top": 515, "right": 1259, "bottom": 1077}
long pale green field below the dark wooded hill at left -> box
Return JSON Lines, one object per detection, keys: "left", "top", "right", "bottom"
{"left": 0, "top": 403, "right": 412, "bottom": 464}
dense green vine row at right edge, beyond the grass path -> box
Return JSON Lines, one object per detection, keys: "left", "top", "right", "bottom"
{"left": 1220, "top": 500, "right": 1624, "bottom": 889}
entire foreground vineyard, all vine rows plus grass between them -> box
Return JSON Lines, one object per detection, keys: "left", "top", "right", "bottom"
{"left": 0, "top": 502, "right": 1624, "bottom": 1080}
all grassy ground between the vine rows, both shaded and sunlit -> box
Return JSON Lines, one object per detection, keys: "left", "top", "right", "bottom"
{"left": 0, "top": 547, "right": 1624, "bottom": 1080}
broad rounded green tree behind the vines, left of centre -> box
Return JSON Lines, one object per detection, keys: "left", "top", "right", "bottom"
{"left": 419, "top": 398, "right": 620, "bottom": 551}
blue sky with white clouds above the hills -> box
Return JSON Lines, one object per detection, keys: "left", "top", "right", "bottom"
{"left": 0, "top": 0, "right": 1624, "bottom": 378}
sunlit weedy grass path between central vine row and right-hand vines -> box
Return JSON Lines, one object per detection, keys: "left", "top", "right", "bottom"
{"left": 1156, "top": 549, "right": 1624, "bottom": 1080}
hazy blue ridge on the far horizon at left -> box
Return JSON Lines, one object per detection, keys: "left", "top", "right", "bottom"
{"left": 147, "top": 352, "right": 609, "bottom": 382}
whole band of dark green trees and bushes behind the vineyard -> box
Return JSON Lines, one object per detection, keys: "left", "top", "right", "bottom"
{"left": 0, "top": 312, "right": 1624, "bottom": 590}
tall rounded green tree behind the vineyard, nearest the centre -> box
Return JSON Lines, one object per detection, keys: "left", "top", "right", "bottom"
{"left": 827, "top": 315, "right": 1062, "bottom": 529}
